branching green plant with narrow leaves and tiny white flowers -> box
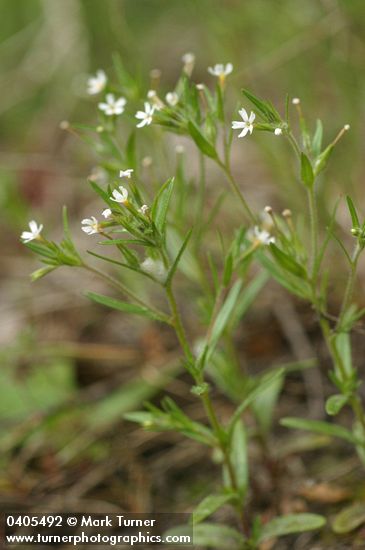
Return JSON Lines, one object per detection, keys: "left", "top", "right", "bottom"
{"left": 21, "top": 54, "right": 365, "bottom": 548}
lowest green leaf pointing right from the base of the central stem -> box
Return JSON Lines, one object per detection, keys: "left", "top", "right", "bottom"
{"left": 258, "top": 514, "right": 326, "bottom": 543}
